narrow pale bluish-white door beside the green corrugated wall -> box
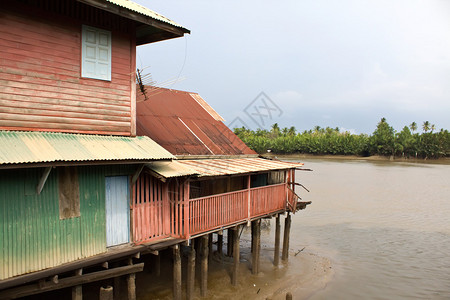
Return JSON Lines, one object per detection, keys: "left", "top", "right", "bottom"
{"left": 105, "top": 176, "right": 130, "bottom": 247}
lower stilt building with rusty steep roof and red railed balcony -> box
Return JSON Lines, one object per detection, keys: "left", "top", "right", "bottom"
{"left": 132, "top": 87, "right": 302, "bottom": 243}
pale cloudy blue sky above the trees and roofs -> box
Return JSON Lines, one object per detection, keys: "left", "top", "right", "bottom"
{"left": 135, "top": 0, "right": 450, "bottom": 134}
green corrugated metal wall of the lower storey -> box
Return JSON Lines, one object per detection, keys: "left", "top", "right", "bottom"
{"left": 0, "top": 166, "right": 135, "bottom": 280}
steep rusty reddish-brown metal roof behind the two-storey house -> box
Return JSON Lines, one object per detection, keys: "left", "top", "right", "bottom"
{"left": 136, "top": 87, "right": 256, "bottom": 155}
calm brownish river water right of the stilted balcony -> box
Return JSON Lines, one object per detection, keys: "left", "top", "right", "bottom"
{"left": 290, "top": 159, "right": 450, "bottom": 300}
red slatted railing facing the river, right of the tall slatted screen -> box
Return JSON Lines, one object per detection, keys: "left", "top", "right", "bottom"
{"left": 188, "top": 183, "right": 287, "bottom": 236}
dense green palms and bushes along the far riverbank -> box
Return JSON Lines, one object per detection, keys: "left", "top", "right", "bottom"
{"left": 234, "top": 118, "right": 450, "bottom": 158}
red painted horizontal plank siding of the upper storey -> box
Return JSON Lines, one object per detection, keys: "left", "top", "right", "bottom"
{"left": 0, "top": 4, "right": 135, "bottom": 135}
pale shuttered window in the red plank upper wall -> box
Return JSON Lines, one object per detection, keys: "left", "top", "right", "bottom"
{"left": 81, "top": 25, "right": 111, "bottom": 81}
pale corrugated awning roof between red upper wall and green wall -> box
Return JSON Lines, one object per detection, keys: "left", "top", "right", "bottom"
{"left": 0, "top": 131, "right": 174, "bottom": 166}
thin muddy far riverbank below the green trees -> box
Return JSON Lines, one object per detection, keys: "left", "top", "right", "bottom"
{"left": 261, "top": 153, "right": 450, "bottom": 165}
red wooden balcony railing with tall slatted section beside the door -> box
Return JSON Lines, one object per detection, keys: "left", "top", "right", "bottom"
{"left": 132, "top": 172, "right": 298, "bottom": 244}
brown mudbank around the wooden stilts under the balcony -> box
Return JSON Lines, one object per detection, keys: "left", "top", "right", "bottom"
{"left": 137, "top": 229, "right": 334, "bottom": 300}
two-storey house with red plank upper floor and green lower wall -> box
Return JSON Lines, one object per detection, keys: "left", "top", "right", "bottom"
{"left": 0, "top": 0, "right": 189, "bottom": 299}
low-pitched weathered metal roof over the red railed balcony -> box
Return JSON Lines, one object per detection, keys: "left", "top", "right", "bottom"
{"left": 178, "top": 158, "right": 303, "bottom": 176}
